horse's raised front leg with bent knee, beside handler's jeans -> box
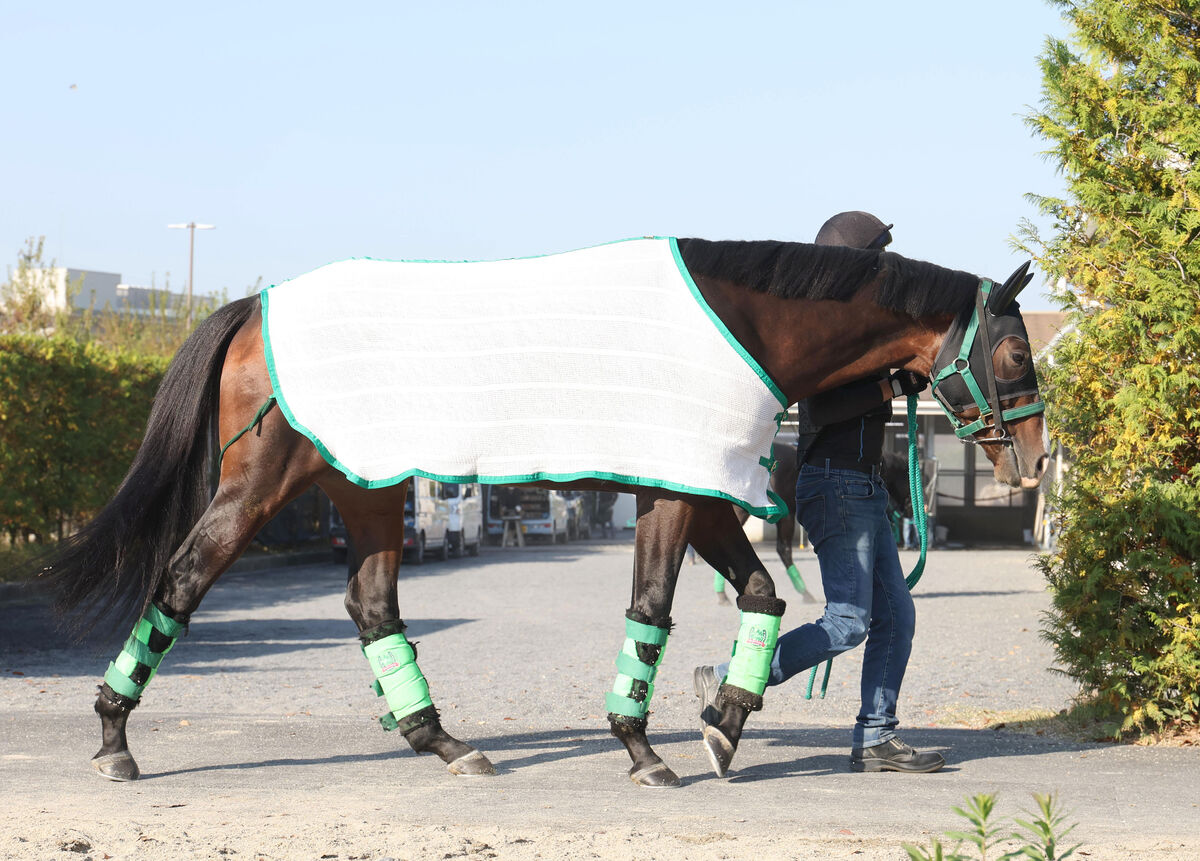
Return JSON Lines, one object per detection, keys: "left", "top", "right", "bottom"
{"left": 690, "top": 505, "right": 785, "bottom": 777}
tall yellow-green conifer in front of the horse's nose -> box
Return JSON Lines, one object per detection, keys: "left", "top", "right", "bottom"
{"left": 1025, "top": 0, "right": 1200, "bottom": 734}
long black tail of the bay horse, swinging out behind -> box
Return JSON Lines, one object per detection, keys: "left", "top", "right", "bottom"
{"left": 42, "top": 296, "right": 258, "bottom": 636}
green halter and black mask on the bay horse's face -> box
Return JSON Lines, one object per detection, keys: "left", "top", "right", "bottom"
{"left": 932, "top": 278, "right": 1045, "bottom": 445}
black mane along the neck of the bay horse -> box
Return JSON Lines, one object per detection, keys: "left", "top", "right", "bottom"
{"left": 679, "top": 239, "right": 979, "bottom": 318}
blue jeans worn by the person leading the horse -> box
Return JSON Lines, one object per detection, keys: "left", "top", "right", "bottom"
{"left": 716, "top": 464, "right": 916, "bottom": 747}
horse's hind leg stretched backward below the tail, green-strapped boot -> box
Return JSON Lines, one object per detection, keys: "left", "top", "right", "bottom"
{"left": 92, "top": 411, "right": 328, "bottom": 781}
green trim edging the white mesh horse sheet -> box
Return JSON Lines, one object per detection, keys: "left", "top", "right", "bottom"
{"left": 258, "top": 242, "right": 787, "bottom": 523}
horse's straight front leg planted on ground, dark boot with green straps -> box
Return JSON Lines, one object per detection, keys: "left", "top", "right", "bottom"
{"left": 605, "top": 490, "right": 696, "bottom": 787}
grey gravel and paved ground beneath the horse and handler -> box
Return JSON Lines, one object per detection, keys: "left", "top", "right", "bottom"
{"left": 0, "top": 542, "right": 1200, "bottom": 861}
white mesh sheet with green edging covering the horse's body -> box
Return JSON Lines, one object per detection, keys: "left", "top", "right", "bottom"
{"left": 262, "top": 239, "right": 786, "bottom": 518}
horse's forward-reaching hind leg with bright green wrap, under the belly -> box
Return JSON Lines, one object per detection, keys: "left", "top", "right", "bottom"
{"left": 322, "top": 476, "right": 496, "bottom": 775}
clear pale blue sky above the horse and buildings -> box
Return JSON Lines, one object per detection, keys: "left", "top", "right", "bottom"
{"left": 0, "top": 0, "right": 1067, "bottom": 311}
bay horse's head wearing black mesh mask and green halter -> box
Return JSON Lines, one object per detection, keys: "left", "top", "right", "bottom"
{"left": 932, "top": 263, "right": 1049, "bottom": 489}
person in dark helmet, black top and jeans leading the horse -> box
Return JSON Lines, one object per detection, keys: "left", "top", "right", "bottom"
{"left": 692, "top": 212, "right": 946, "bottom": 775}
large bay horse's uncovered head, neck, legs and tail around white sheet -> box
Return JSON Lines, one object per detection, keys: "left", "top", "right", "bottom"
{"left": 42, "top": 239, "right": 1048, "bottom": 787}
